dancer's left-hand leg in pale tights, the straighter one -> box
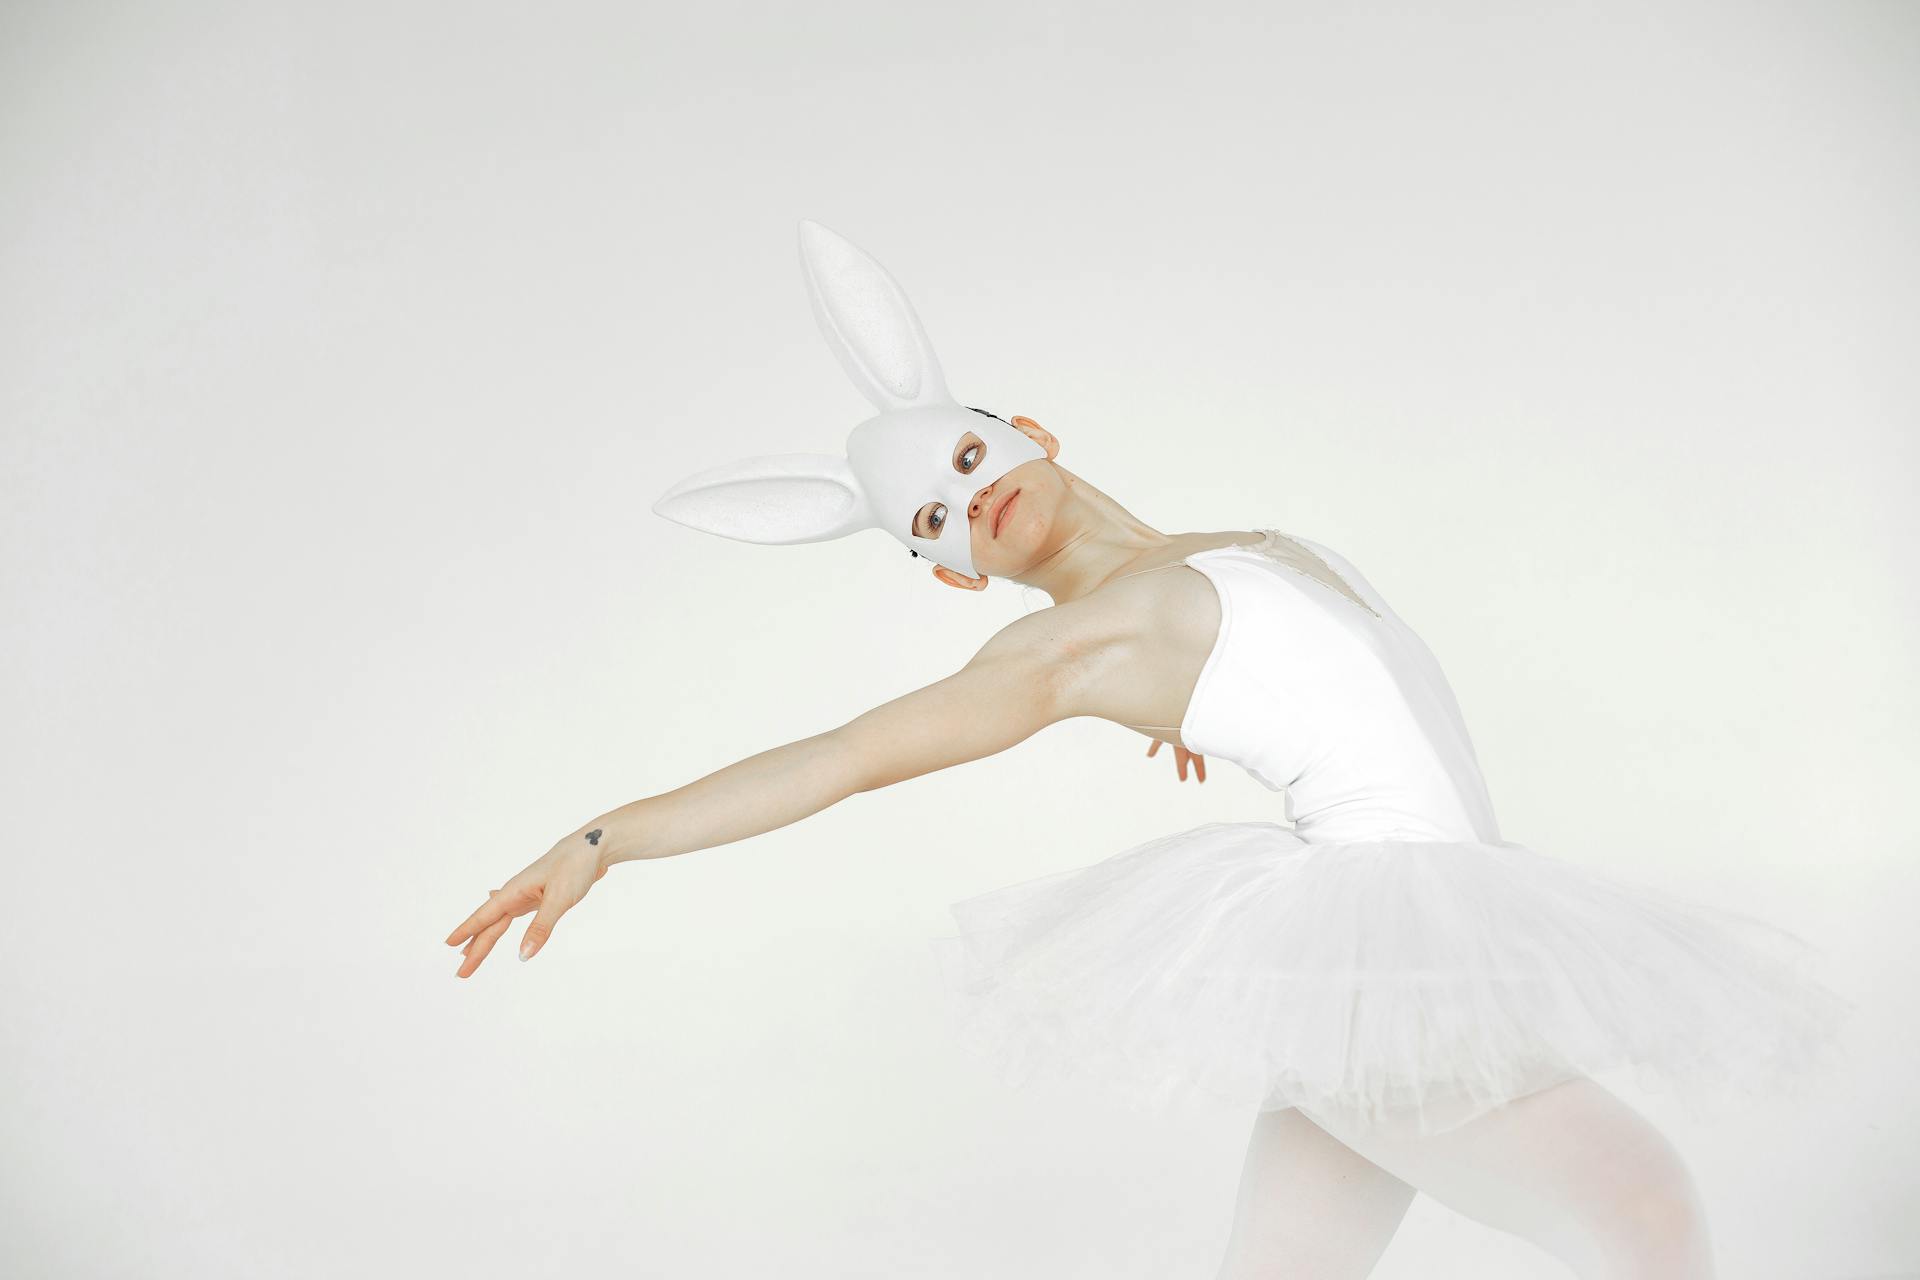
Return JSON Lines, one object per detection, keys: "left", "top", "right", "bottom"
{"left": 1215, "top": 1107, "right": 1413, "bottom": 1280}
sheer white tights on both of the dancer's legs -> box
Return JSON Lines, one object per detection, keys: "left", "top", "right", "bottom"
{"left": 1217, "top": 1079, "right": 1715, "bottom": 1280}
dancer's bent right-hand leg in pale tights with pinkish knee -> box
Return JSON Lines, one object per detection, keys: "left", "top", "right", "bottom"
{"left": 1313, "top": 1077, "right": 1715, "bottom": 1280}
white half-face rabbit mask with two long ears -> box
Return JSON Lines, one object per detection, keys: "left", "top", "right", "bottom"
{"left": 653, "top": 219, "right": 1046, "bottom": 578}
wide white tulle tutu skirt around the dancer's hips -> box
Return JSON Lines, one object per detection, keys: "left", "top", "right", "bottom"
{"left": 931, "top": 821, "right": 1855, "bottom": 1132}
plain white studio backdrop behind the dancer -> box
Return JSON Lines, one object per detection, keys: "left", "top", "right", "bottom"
{"left": 0, "top": 0, "right": 1920, "bottom": 1280}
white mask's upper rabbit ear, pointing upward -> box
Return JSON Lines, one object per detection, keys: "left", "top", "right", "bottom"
{"left": 801, "top": 219, "right": 952, "bottom": 413}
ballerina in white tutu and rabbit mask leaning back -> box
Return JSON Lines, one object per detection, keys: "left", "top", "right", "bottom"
{"left": 447, "top": 223, "right": 1851, "bottom": 1280}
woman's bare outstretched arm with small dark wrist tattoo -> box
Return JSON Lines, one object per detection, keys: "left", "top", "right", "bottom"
{"left": 447, "top": 608, "right": 1094, "bottom": 977}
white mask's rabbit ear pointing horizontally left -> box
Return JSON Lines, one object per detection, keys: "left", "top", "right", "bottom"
{"left": 653, "top": 453, "right": 872, "bottom": 543}
